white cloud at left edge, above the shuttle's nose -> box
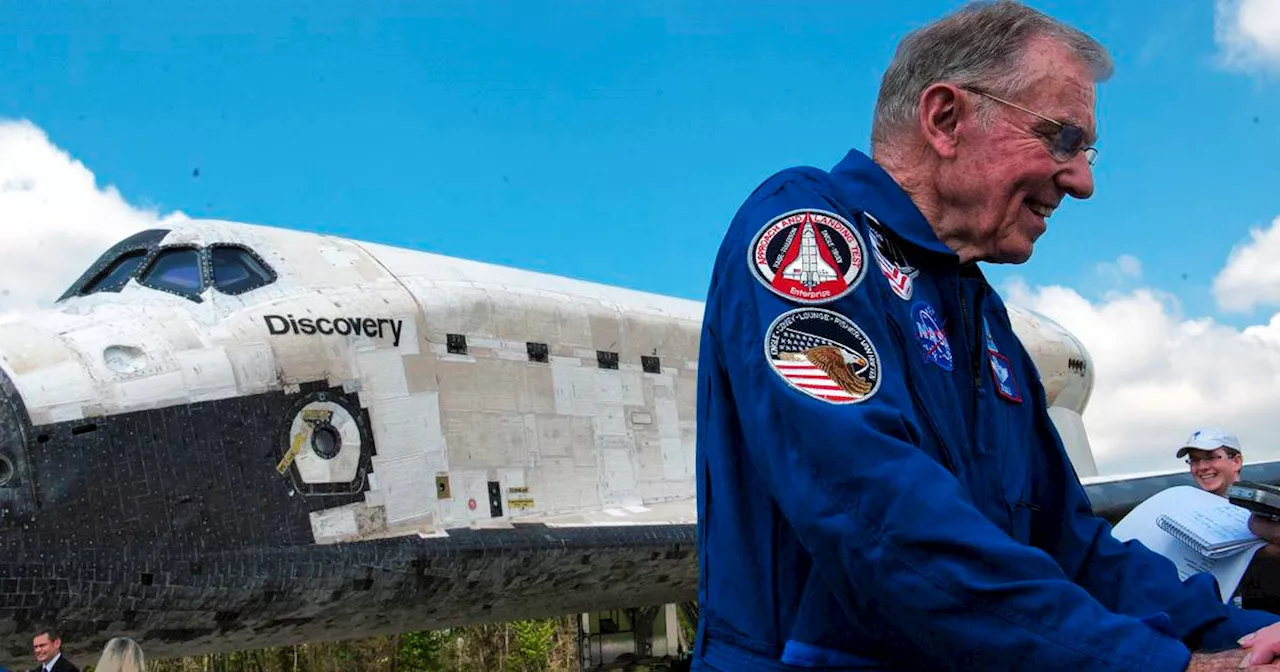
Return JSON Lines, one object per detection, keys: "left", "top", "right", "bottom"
{"left": 0, "top": 120, "right": 186, "bottom": 319}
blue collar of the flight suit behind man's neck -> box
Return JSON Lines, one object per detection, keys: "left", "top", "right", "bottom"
{"left": 831, "top": 150, "right": 959, "bottom": 261}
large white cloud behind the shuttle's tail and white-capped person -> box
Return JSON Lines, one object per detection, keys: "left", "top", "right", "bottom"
{"left": 1005, "top": 273, "right": 1280, "bottom": 474}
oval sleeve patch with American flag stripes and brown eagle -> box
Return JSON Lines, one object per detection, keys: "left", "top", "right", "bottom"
{"left": 764, "top": 308, "right": 882, "bottom": 404}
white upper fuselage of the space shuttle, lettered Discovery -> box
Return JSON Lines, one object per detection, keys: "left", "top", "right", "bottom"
{"left": 0, "top": 221, "right": 1096, "bottom": 543}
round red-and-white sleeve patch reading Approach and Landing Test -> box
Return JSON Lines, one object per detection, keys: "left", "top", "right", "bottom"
{"left": 750, "top": 210, "right": 867, "bottom": 305}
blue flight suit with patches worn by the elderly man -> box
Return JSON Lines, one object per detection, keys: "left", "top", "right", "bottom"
{"left": 694, "top": 151, "right": 1277, "bottom": 672}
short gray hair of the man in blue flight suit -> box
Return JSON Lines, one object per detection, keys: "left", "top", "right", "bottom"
{"left": 872, "top": 0, "right": 1115, "bottom": 145}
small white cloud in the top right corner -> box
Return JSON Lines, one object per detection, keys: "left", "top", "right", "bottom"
{"left": 1213, "top": 0, "right": 1280, "bottom": 72}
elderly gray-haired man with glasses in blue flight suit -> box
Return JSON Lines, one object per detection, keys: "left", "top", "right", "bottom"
{"left": 694, "top": 1, "right": 1280, "bottom": 672}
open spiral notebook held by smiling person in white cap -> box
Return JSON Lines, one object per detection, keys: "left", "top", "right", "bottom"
{"left": 1156, "top": 493, "right": 1263, "bottom": 558}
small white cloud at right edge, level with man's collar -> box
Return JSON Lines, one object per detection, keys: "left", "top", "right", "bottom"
{"left": 1213, "top": 216, "right": 1280, "bottom": 312}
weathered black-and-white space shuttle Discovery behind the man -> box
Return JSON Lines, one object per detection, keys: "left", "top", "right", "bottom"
{"left": 0, "top": 220, "right": 1280, "bottom": 664}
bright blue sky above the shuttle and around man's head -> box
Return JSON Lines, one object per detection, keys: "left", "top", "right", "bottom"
{"left": 0, "top": 0, "right": 1280, "bottom": 323}
